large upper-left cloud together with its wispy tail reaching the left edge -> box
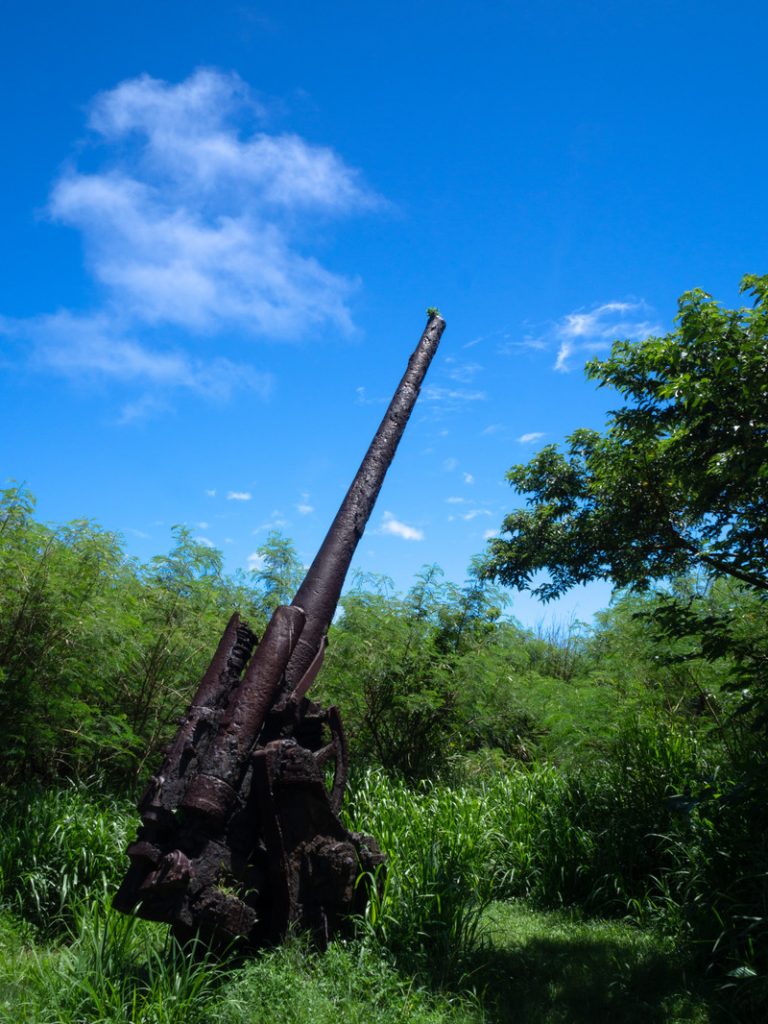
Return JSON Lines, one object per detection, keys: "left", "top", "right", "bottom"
{"left": 0, "top": 69, "right": 380, "bottom": 422}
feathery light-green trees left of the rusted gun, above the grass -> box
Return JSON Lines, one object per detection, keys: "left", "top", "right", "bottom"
{"left": 0, "top": 487, "right": 260, "bottom": 782}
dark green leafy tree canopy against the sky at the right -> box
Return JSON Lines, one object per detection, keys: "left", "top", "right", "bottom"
{"left": 483, "top": 275, "right": 768, "bottom": 600}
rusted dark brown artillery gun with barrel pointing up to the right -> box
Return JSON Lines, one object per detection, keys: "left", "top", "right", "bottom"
{"left": 114, "top": 310, "right": 445, "bottom": 947}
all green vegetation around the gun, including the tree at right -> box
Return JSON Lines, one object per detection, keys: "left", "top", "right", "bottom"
{"left": 0, "top": 279, "right": 768, "bottom": 1024}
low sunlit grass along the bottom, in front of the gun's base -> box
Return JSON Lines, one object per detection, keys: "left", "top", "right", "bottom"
{"left": 0, "top": 905, "right": 483, "bottom": 1024}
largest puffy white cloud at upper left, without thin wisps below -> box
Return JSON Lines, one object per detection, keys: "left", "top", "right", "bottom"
{"left": 45, "top": 70, "right": 377, "bottom": 335}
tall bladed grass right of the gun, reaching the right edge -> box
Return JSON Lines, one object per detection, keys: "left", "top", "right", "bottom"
{"left": 351, "top": 725, "right": 768, "bottom": 1012}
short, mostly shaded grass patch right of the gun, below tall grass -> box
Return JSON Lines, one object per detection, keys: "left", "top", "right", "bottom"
{"left": 444, "top": 904, "right": 720, "bottom": 1024}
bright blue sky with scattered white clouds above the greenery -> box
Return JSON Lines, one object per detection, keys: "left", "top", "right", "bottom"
{"left": 0, "top": 0, "right": 768, "bottom": 625}
